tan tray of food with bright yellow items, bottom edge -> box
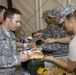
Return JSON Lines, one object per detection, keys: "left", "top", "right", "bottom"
{"left": 37, "top": 67, "right": 74, "bottom": 75}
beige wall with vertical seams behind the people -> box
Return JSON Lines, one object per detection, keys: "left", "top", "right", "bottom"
{"left": 0, "top": 0, "right": 76, "bottom": 38}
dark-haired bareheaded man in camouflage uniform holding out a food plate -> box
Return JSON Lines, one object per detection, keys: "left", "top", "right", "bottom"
{"left": 0, "top": 8, "right": 29, "bottom": 75}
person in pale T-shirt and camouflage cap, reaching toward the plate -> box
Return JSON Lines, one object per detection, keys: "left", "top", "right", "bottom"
{"left": 44, "top": 4, "right": 76, "bottom": 72}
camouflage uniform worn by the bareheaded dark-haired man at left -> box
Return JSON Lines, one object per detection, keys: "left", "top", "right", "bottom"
{"left": 0, "top": 25, "right": 20, "bottom": 75}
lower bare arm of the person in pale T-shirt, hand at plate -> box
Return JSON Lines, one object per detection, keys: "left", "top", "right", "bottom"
{"left": 44, "top": 56, "right": 76, "bottom": 71}
